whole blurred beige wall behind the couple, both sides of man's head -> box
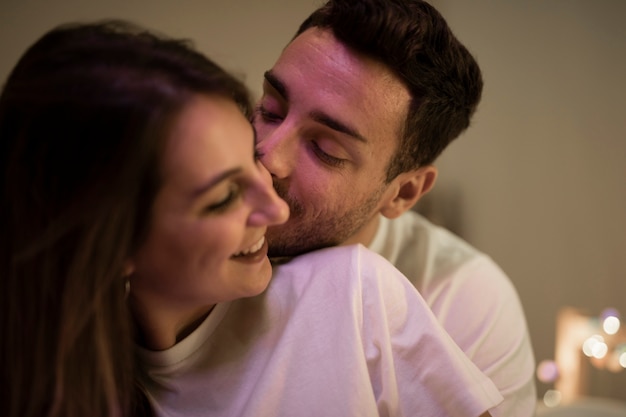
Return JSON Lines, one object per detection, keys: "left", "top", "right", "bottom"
{"left": 0, "top": 0, "right": 626, "bottom": 399}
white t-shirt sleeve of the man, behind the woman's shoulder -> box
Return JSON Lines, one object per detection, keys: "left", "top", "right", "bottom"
{"left": 424, "top": 255, "right": 536, "bottom": 417}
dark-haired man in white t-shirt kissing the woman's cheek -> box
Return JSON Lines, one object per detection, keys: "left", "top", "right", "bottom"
{"left": 254, "top": 0, "right": 536, "bottom": 416}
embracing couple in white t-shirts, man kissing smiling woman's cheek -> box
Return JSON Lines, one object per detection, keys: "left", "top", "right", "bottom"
{"left": 0, "top": 0, "right": 534, "bottom": 416}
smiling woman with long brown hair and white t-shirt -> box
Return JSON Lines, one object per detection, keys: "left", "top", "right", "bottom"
{"left": 0, "top": 19, "right": 501, "bottom": 417}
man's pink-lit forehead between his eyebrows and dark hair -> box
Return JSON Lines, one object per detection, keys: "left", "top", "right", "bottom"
{"left": 266, "top": 28, "right": 411, "bottom": 150}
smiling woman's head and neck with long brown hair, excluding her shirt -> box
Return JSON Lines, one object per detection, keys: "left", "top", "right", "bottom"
{"left": 0, "top": 22, "right": 288, "bottom": 417}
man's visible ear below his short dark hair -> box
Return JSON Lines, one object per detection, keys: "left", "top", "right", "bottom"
{"left": 380, "top": 165, "right": 437, "bottom": 219}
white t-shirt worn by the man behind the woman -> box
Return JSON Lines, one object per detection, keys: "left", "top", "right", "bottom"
{"left": 370, "top": 211, "right": 537, "bottom": 417}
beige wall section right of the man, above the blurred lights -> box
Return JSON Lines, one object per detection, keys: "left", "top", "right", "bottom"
{"left": 435, "top": 0, "right": 626, "bottom": 399}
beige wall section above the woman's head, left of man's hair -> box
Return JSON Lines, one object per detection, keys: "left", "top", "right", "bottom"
{"left": 0, "top": 0, "right": 320, "bottom": 99}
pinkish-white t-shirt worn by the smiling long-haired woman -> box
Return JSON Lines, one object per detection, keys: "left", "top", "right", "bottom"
{"left": 139, "top": 245, "right": 502, "bottom": 417}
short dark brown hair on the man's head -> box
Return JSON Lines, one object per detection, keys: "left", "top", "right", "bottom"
{"left": 296, "top": 0, "right": 483, "bottom": 181}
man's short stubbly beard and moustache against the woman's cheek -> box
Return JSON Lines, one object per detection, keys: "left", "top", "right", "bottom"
{"left": 266, "top": 182, "right": 383, "bottom": 258}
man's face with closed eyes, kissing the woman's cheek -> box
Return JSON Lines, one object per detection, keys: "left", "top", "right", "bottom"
{"left": 254, "top": 28, "right": 410, "bottom": 256}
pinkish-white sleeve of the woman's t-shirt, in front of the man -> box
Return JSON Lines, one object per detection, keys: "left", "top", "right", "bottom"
{"left": 355, "top": 246, "right": 502, "bottom": 417}
